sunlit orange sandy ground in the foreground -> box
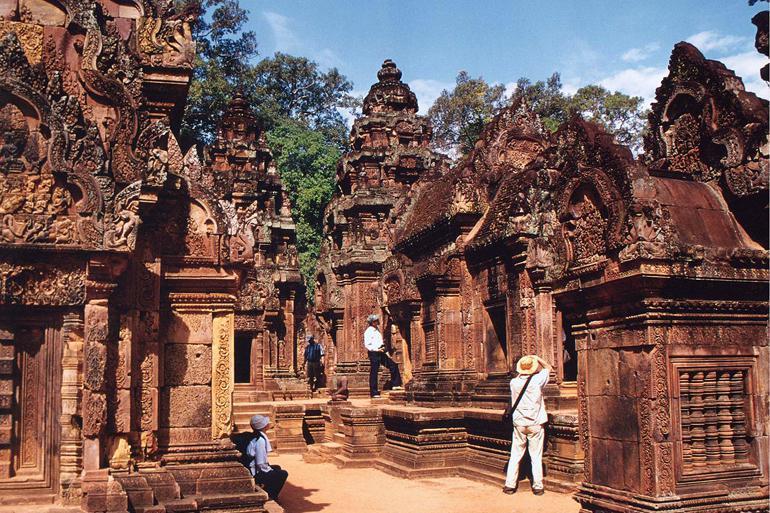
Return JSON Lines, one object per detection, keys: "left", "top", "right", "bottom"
{"left": 270, "top": 454, "right": 580, "bottom": 513}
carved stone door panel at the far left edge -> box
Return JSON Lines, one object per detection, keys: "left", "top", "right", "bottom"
{"left": 0, "top": 313, "right": 60, "bottom": 504}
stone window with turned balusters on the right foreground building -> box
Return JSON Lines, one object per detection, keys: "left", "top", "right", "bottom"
{"left": 674, "top": 357, "right": 758, "bottom": 481}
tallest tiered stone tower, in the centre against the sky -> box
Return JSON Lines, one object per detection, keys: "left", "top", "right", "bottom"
{"left": 315, "top": 60, "right": 442, "bottom": 394}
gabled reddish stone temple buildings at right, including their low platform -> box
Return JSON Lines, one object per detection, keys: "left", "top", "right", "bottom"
{"left": 298, "top": 25, "right": 770, "bottom": 513}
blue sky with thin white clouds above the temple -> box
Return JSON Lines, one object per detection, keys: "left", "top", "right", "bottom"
{"left": 241, "top": 0, "right": 770, "bottom": 112}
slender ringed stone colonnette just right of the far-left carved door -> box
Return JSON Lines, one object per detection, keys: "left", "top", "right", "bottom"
{"left": 59, "top": 312, "right": 83, "bottom": 500}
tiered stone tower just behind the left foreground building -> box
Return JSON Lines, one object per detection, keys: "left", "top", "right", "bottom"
{"left": 201, "top": 94, "right": 305, "bottom": 401}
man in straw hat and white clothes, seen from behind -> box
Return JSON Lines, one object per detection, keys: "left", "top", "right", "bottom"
{"left": 503, "top": 355, "right": 551, "bottom": 495}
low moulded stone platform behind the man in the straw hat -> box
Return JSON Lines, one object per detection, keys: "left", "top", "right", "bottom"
{"left": 236, "top": 393, "right": 582, "bottom": 493}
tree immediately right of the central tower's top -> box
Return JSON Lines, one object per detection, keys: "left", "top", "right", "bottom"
{"left": 428, "top": 71, "right": 505, "bottom": 154}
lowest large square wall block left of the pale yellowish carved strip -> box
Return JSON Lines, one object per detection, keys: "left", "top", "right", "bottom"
{"left": 160, "top": 386, "right": 211, "bottom": 427}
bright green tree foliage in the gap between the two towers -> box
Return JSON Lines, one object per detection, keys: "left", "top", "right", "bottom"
{"left": 267, "top": 119, "right": 341, "bottom": 290}
